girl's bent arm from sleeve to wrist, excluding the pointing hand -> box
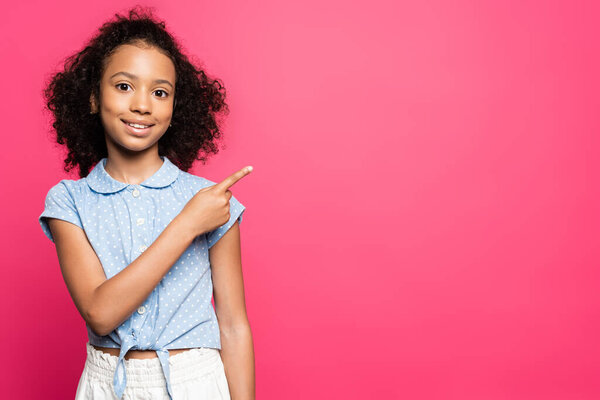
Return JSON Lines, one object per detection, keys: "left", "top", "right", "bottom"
{"left": 48, "top": 214, "right": 196, "bottom": 336}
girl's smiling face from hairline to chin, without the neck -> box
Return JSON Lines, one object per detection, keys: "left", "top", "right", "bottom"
{"left": 98, "top": 45, "right": 175, "bottom": 154}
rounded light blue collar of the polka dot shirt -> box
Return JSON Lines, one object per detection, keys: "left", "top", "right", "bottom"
{"left": 85, "top": 156, "right": 179, "bottom": 193}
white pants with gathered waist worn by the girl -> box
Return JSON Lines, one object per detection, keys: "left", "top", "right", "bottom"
{"left": 75, "top": 342, "right": 231, "bottom": 400}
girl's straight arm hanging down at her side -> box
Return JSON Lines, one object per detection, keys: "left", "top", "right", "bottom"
{"left": 209, "top": 222, "right": 255, "bottom": 400}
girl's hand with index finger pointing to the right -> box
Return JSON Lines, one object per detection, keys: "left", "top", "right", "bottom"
{"left": 179, "top": 166, "right": 252, "bottom": 237}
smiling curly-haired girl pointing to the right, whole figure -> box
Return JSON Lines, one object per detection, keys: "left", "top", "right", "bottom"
{"left": 39, "top": 8, "right": 254, "bottom": 400}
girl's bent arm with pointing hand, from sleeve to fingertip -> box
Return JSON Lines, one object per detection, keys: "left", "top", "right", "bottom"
{"left": 48, "top": 168, "right": 250, "bottom": 336}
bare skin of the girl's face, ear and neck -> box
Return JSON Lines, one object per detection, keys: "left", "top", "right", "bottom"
{"left": 90, "top": 41, "right": 175, "bottom": 184}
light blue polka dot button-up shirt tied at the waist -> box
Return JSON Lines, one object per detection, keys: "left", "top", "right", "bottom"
{"left": 39, "top": 156, "right": 245, "bottom": 399}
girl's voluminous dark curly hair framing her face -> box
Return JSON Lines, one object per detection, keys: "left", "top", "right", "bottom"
{"left": 43, "top": 6, "right": 229, "bottom": 178}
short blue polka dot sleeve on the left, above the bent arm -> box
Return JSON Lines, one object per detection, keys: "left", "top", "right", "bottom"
{"left": 38, "top": 181, "right": 83, "bottom": 242}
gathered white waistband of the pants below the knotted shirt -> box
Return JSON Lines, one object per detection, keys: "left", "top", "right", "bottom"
{"left": 85, "top": 342, "right": 221, "bottom": 387}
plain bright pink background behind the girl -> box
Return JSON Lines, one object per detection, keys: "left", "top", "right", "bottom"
{"left": 0, "top": 0, "right": 600, "bottom": 400}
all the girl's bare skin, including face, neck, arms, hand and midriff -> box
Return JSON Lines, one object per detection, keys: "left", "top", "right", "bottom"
{"left": 48, "top": 44, "right": 255, "bottom": 400}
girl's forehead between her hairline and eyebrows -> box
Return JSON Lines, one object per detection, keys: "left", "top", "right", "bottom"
{"left": 103, "top": 44, "right": 175, "bottom": 82}
